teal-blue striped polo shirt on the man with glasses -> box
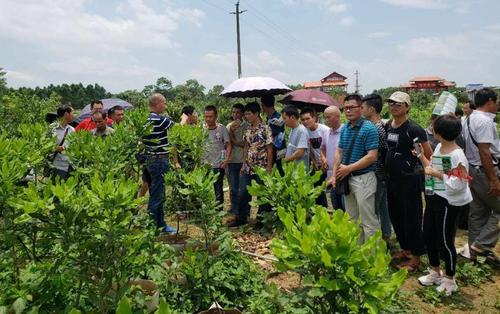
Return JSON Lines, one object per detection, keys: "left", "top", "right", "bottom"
{"left": 339, "top": 117, "right": 379, "bottom": 175}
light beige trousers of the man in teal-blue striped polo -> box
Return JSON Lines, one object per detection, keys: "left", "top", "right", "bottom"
{"left": 344, "top": 172, "right": 380, "bottom": 243}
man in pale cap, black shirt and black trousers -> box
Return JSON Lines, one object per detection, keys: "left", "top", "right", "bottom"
{"left": 385, "top": 92, "right": 432, "bottom": 271}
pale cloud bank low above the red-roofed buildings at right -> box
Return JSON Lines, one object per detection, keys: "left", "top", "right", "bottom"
{"left": 285, "top": 25, "right": 500, "bottom": 93}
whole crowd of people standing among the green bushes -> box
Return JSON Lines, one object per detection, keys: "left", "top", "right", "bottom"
{"left": 48, "top": 88, "right": 500, "bottom": 295}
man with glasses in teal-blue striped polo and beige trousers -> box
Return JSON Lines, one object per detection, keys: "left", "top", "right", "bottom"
{"left": 330, "top": 94, "right": 380, "bottom": 242}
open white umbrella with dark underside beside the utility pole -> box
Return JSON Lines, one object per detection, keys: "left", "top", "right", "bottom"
{"left": 220, "top": 76, "right": 291, "bottom": 98}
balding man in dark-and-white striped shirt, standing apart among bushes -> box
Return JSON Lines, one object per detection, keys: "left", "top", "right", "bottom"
{"left": 143, "top": 93, "right": 176, "bottom": 233}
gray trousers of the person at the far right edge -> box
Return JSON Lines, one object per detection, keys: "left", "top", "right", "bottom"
{"left": 469, "top": 167, "right": 500, "bottom": 250}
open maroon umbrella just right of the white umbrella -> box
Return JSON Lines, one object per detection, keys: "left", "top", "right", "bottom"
{"left": 281, "top": 89, "right": 340, "bottom": 112}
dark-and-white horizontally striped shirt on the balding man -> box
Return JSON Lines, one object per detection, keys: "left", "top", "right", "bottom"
{"left": 142, "top": 112, "right": 174, "bottom": 155}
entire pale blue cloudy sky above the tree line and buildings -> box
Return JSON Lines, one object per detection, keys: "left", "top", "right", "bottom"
{"left": 0, "top": 0, "right": 500, "bottom": 94}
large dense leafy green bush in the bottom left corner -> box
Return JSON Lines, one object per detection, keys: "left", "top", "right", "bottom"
{"left": 2, "top": 174, "right": 174, "bottom": 312}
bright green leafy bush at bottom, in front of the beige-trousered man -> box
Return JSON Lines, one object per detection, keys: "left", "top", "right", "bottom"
{"left": 271, "top": 205, "right": 406, "bottom": 313}
